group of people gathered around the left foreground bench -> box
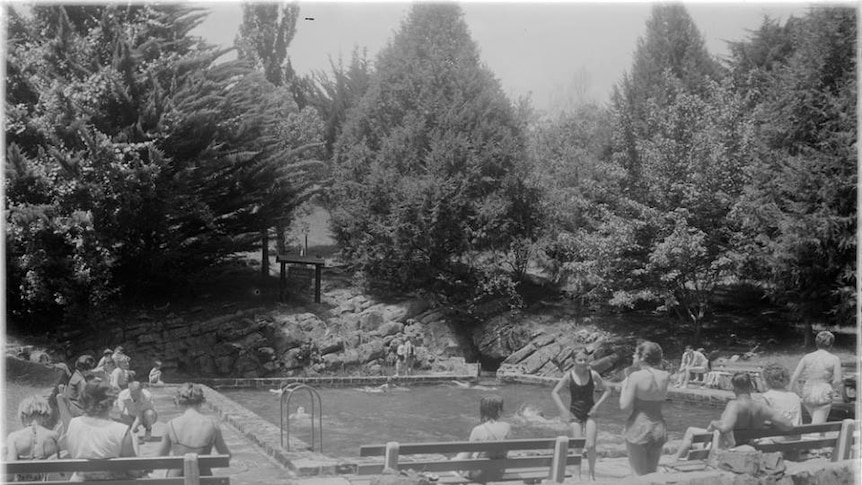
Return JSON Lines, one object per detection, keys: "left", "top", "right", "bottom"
{"left": 5, "top": 347, "right": 230, "bottom": 481}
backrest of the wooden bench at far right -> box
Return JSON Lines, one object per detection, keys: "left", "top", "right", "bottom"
{"left": 688, "top": 419, "right": 857, "bottom": 461}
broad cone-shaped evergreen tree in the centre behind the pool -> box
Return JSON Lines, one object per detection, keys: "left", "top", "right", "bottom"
{"left": 332, "top": 4, "right": 537, "bottom": 294}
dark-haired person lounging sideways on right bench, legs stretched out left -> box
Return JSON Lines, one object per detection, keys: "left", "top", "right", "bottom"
{"left": 676, "top": 372, "right": 793, "bottom": 461}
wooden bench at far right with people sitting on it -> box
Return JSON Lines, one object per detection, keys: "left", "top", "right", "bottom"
{"left": 663, "top": 419, "right": 857, "bottom": 471}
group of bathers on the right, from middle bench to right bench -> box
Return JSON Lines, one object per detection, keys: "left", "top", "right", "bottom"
{"left": 460, "top": 331, "right": 843, "bottom": 481}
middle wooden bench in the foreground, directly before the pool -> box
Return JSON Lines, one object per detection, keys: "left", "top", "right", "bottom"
{"left": 357, "top": 436, "right": 586, "bottom": 483}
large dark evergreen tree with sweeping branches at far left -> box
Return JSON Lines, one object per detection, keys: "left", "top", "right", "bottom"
{"left": 4, "top": 5, "right": 318, "bottom": 324}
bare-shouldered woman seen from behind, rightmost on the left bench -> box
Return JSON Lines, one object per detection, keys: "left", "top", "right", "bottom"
{"left": 158, "top": 383, "right": 230, "bottom": 477}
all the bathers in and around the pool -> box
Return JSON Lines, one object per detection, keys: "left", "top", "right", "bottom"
{"left": 6, "top": 332, "right": 843, "bottom": 482}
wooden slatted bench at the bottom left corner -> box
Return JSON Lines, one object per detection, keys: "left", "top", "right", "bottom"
{"left": 3, "top": 453, "right": 230, "bottom": 485}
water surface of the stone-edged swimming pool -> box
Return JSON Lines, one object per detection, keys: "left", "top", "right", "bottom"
{"left": 220, "top": 384, "right": 721, "bottom": 457}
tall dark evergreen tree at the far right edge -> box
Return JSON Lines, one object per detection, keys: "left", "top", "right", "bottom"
{"left": 736, "top": 7, "right": 858, "bottom": 344}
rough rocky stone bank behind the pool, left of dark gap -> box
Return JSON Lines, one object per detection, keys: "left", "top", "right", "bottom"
{"left": 59, "top": 296, "right": 472, "bottom": 382}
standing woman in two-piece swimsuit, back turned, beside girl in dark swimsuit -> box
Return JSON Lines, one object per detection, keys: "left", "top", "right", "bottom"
{"left": 620, "top": 341, "right": 670, "bottom": 475}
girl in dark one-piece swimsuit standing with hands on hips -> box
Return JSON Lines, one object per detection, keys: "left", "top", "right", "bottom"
{"left": 551, "top": 349, "right": 611, "bottom": 480}
